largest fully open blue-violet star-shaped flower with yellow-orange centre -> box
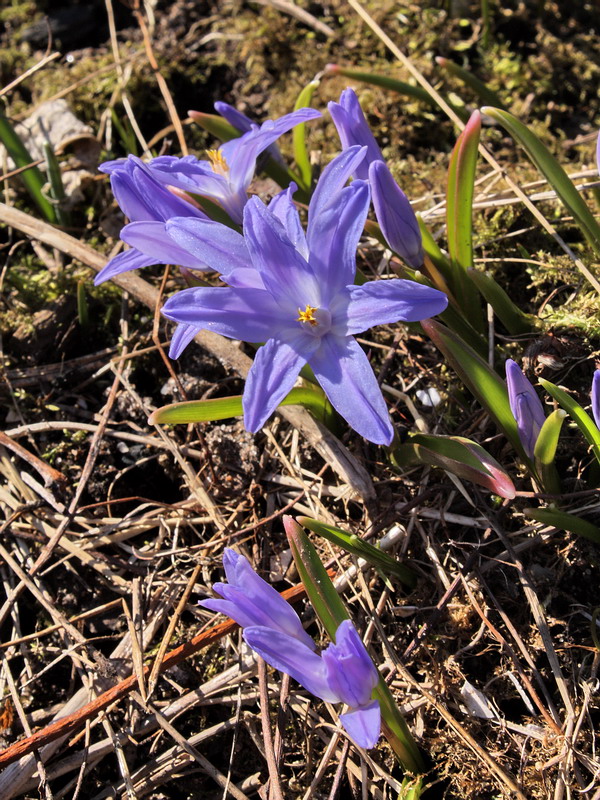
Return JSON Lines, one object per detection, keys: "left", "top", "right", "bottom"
{"left": 163, "top": 147, "right": 447, "bottom": 444}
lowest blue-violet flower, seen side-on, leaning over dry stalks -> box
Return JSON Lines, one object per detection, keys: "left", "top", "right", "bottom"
{"left": 200, "top": 549, "right": 381, "bottom": 748}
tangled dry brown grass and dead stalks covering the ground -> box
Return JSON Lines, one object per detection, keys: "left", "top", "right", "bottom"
{"left": 0, "top": 1, "right": 600, "bottom": 800}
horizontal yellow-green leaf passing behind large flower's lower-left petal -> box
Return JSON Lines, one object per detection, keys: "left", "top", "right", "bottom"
{"left": 148, "top": 386, "right": 330, "bottom": 425}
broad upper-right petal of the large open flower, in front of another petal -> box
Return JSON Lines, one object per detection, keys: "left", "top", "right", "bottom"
{"left": 310, "top": 179, "right": 371, "bottom": 306}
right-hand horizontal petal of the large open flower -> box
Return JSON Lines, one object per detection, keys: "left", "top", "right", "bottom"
{"left": 330, "top": 278, "right": 448, "bottom": 335}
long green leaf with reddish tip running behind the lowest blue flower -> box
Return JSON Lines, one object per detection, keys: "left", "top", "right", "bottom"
{"left": 283, "top": 516, "right": 425, "bottom": 774}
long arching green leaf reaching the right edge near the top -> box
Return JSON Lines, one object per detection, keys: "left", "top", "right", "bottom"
{"left": 481, "top": 106, "right": 600, "bottom": 255}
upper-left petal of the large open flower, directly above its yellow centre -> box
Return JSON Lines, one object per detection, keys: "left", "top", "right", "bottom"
{"left": 244, "top": 197, "right": 321, "bottom": 310}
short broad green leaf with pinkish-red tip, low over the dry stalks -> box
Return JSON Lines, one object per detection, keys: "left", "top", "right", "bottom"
{"left": 391, "top": 433, "right": 515, "bottom": 500}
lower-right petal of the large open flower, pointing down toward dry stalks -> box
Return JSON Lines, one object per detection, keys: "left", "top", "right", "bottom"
{"left": 308, "top": 334, "right": 394, "bottom": 445}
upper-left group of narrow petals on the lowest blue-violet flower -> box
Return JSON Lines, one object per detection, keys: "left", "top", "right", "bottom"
{"left": 200, "top": 548, "right": 315, "bottom": 650}
